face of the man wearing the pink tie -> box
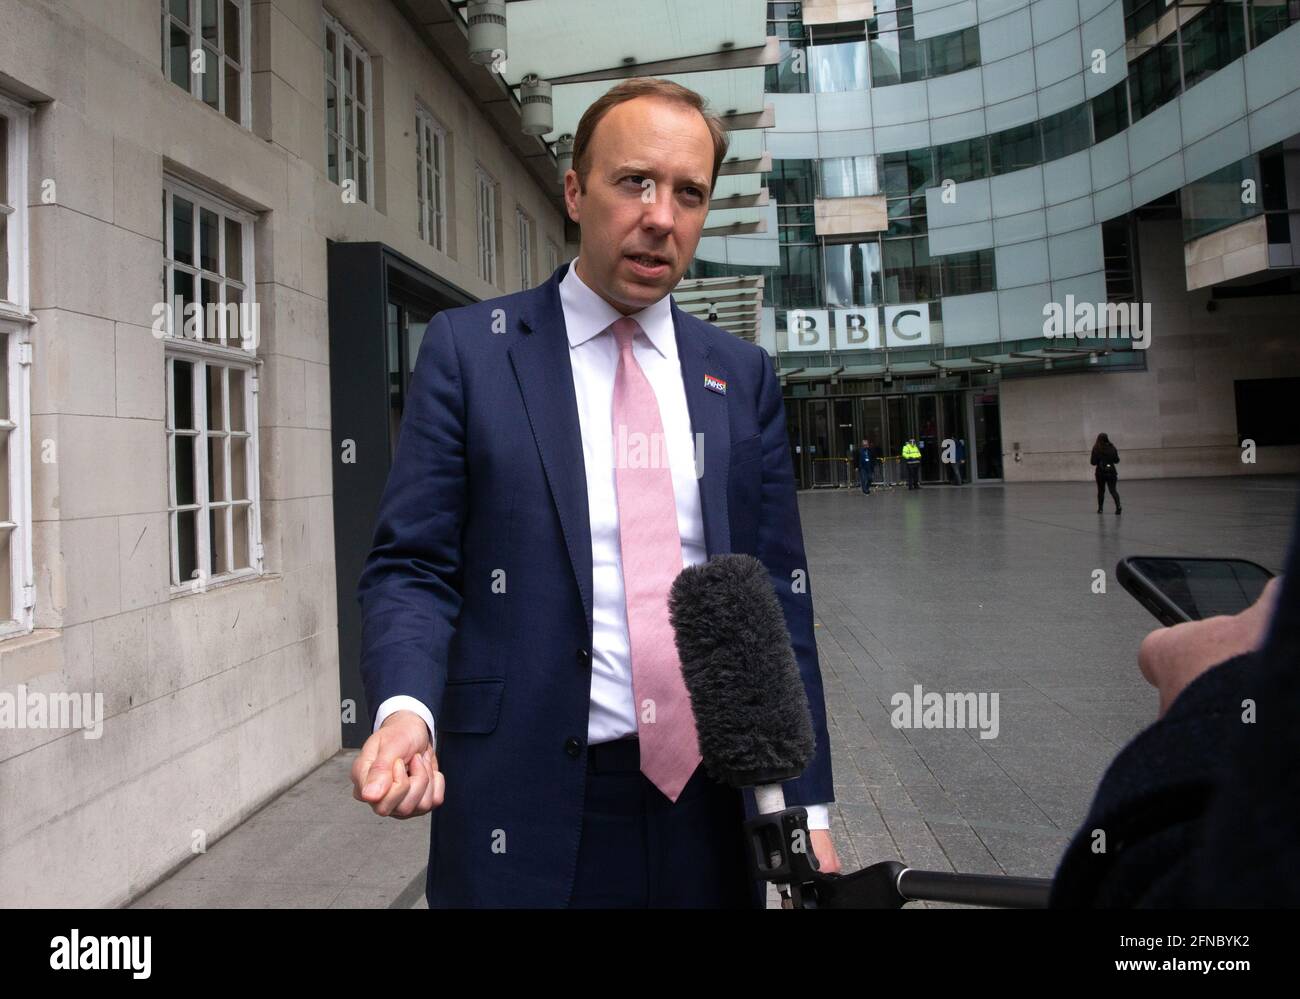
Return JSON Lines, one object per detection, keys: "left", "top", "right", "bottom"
{"left": 564, "top": 96, "right": 714, "bottom": 315}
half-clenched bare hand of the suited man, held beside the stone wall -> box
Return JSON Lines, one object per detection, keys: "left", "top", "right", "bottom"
{"left": 352, "top": 712, "right": 446, "bottom": 818}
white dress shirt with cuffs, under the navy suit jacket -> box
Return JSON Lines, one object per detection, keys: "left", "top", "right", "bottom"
{"left": 374, "top": 253, "right": 829, "bottom": 829}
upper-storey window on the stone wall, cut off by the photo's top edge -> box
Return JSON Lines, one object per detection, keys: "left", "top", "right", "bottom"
{"left": 161, "top": 0, "right": 251, "bottom": 126}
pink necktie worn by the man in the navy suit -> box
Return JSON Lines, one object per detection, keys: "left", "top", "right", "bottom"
{"left": 610, "top": 316, "right": 699, "bottom": 801}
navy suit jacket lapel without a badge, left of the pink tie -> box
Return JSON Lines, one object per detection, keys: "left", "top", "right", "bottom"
{"left": 510, "top": 264, "right": 592, "bottom": 631}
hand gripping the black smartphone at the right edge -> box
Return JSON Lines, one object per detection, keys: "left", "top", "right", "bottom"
{"left": 1138, "top": 578, "right": 1282, "bottom": 717}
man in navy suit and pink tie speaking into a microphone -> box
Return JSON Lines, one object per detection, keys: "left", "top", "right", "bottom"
{"left": 352, "top": 79, "right": 839, "bottom": 907}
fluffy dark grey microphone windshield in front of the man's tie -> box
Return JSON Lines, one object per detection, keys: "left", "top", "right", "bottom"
{"left": 668, "top": 554, "right": 816, "bottom": 787}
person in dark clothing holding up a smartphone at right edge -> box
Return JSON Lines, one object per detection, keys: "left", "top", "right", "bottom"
{"left": 1050, "top": 494, "right": 1300, "bottom": 908}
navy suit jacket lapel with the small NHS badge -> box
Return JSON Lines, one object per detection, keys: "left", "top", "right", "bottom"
{"left": 672, "top": 302, "right": 731, "bottom": 555}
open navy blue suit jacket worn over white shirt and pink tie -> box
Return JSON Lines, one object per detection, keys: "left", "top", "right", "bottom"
{"left": 358, "top": 264, "right": 835, "bottom": 907}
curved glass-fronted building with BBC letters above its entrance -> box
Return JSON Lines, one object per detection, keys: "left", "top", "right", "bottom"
{"left": 690, "top": 0, "right": 1300, "bottom": 486}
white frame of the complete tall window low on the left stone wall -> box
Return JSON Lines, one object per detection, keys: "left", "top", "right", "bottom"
{"left": 161, "top": 174, "right": 265, "bottom": 596}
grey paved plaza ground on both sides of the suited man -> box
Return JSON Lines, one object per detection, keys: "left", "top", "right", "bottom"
{"left": 129, "top": 476, "right": 1300, "bottom": 908}
